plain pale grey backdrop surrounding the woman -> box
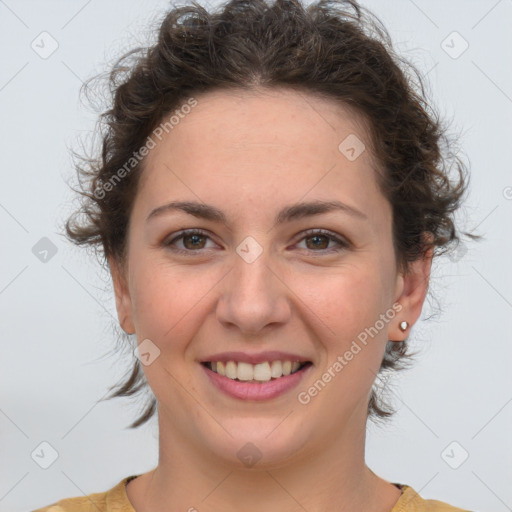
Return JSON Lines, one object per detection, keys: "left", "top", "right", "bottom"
{"left": 0, "top": 0, "right": 512, "bottom": 512}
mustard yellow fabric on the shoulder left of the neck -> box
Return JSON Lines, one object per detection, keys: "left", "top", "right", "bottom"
{"left": 31, "top": 476, "right": 135, "bottom": 512}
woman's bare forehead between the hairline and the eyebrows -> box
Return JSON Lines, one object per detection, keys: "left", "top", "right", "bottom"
{"left": 134, "top": 89, "right": 386, "bottom": 228}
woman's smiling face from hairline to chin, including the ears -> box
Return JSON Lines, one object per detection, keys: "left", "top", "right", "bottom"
{"left": 111, "top": 90, "right": 429, "bottom": 467}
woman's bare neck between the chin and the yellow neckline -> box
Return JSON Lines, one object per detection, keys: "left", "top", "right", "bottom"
{"left": 127, "top": 404, "right": 400, "bottom": 512}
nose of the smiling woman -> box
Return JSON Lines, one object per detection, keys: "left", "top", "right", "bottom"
{"left": 216, "top": 247, "right": 291, "bottom": 336}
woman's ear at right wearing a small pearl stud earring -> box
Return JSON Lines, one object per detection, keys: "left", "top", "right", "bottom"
{"left": 388, "top": 233, "right": 434, "bottom": 341}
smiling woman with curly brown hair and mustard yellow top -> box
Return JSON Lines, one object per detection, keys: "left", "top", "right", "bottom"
{"left": 34, "top": 0, "right": 478, "bottom": 512}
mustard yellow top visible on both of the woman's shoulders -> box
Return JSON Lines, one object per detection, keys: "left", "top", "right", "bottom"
{"left": 32, "top": 475, "right": 469, "bottom": 512}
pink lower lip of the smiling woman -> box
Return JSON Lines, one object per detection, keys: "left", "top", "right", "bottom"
{"left": 201, "top": 364, "right": 312, "bottom": 401}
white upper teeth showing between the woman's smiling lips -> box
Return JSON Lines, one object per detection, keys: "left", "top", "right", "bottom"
{"left": 201, "top": 361, "right": 312, "bottom": 383}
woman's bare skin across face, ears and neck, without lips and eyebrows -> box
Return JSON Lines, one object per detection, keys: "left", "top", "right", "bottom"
{"left": 110, "top": 89, "right": 432, "bottom": 512}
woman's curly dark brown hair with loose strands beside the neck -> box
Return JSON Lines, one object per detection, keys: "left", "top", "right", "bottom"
{"left": 66, "top": 0, "right": 479, "bottom": 428}
